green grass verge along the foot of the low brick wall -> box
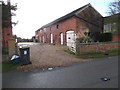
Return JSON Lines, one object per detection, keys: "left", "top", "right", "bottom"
{"left": 64, "top": 49, "right": 120, "bottom": 59}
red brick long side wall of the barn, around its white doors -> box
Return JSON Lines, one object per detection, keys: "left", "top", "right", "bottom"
{"left": 39, "top": 17, "right": 76, "bottom": 44}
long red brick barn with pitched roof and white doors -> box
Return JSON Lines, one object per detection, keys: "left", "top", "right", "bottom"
{"left": 35, "top": 4, "right": 103, "bottom": 46}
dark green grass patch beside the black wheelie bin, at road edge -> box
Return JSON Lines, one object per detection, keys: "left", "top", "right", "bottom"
{"left": 2, "top": 61, "right": 19, "bottom": 72}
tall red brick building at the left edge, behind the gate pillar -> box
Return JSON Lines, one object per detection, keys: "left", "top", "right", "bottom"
{"left": 2, "top": 0, "right": 13, "bottom": 48}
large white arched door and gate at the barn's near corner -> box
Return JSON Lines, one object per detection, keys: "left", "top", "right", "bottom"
{"left": 66, "top": 31, "right": 76, "bottom": 52}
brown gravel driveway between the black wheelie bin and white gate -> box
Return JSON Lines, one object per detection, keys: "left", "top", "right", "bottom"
{"left": 17, "top": 45, "right": 90, "bottom": 70}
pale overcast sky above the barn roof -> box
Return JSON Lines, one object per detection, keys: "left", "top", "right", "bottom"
{"left": 7, "top": 0, "right": 113, "bottom": 38}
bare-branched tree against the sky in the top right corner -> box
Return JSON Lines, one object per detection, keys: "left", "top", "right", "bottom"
{"left": 108, "top": 0, "right": 120, "bottom": 15}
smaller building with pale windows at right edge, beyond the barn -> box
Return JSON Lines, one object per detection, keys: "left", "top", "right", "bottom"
{"left": 103, "top": 13, "right": 120, "bottom": 41}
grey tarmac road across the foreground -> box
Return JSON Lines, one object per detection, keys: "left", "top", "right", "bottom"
{"left": 2, "top": 56, "right": 118, "bottom": 88}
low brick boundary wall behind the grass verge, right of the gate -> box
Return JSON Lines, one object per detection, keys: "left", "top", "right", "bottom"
{"left": 76, "top": 42, "right": 120, "bottom": 54}
